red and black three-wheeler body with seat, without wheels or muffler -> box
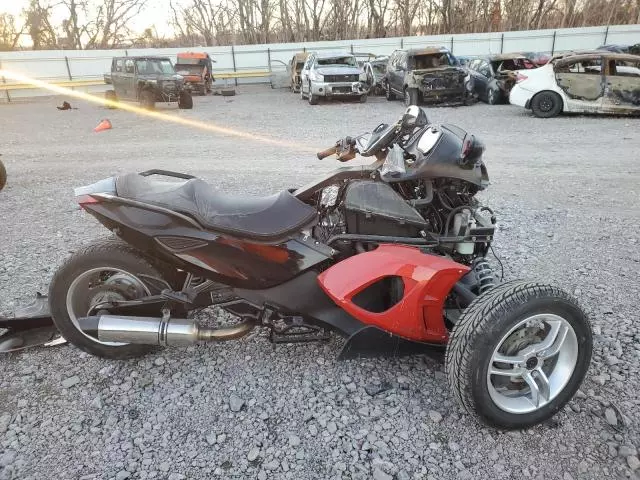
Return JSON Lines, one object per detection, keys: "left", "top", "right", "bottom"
{"left": 76, "top": 125, "right": 493, "bottom": 354}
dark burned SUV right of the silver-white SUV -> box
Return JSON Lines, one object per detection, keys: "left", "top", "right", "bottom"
{"left": 384, "top": 47, "right": 474, "bottom": 105}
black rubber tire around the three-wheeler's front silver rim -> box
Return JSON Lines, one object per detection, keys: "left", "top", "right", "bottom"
{"left": 446, "top": 281, "right": 593, "bottom": 429}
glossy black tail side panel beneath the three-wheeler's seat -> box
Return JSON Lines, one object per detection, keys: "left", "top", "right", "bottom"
{"left": 85, "top": 201, "right": 331, "bottom": 289}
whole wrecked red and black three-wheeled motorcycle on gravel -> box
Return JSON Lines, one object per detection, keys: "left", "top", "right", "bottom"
{"left": 49, "top": 106, "right": 592, "bottom": 428}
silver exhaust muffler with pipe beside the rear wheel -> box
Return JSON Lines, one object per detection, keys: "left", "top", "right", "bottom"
{"left": 78, "top": 315, "right": 255, "bottom": 346}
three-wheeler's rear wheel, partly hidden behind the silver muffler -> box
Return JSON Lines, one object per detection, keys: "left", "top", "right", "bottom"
{"left": 49, "top": 239, "right": 168, "bottom": 359}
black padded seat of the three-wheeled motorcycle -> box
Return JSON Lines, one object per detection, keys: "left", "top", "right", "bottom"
{"left": 116, "top": 173, "right": 316, "bottom": 241}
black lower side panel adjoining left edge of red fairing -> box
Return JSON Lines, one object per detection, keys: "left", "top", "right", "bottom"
{"left": 234, "top": 271, "right": 365, "bottom": 337}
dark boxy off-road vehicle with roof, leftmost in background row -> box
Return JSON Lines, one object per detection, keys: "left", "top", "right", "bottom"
{"left": 105, "top": 56, "right": 193, "bottom": 109}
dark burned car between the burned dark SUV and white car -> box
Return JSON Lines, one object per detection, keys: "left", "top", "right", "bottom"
{"left": 467, "top": 53, "right": 537, "bottom": 105}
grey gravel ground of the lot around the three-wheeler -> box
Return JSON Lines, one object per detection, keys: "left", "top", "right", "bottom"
{"left": 0, "top": 87, "right": 640, "bottom": 480}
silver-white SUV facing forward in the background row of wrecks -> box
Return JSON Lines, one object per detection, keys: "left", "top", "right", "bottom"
{"left": 300, "top": 52, "right": 367, "bottom": 105}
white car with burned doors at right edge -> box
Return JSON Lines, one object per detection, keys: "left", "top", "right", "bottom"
{"left": 509, "top": 51, "right": 640, "bottom": 118}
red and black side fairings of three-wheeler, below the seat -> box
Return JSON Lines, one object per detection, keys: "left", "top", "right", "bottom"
{"left": 79, "top": 177, "right": 469, "bottom": 357}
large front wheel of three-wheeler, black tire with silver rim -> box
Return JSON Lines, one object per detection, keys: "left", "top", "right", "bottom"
{"left": 446, "top": 281, "right": 593, "bottom": 429}
